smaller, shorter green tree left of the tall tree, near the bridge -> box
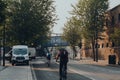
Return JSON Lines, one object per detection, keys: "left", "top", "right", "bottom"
{"left": 63, "top": 17, "right": 81, "bottom": 59}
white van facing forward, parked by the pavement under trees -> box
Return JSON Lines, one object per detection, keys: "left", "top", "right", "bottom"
{"left": 11, "top": 45, "right": 29, "bottom": 65}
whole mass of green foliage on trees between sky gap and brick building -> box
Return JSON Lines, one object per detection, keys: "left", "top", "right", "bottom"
{"left": 63, "top": 0, "right": 108, "bottom": 57}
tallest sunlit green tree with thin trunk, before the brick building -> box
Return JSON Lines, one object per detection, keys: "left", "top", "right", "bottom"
{"left": 68, "top": 0, "right": 108, "bottom": 61}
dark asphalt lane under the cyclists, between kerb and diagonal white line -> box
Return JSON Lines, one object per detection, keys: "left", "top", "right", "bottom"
{"left": 31, "top": 58, "right": 92, "bottom": 80}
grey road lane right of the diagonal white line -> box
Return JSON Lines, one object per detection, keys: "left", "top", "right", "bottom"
{"left": 69, "top": 61, "right": 120, "bottom": 80}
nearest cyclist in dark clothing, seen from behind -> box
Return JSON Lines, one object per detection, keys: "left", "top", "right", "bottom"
{"left": 56, "top": 48, "right": 68, "bottom": 80}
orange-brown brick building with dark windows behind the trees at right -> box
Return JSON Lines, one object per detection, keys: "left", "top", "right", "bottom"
{"left": 85, "top": 5, "right": 120, "bottom": 61}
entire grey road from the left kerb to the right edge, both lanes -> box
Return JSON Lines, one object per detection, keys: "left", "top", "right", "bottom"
{"left": 31, "top": 58, "right": 120, "bottom": 80}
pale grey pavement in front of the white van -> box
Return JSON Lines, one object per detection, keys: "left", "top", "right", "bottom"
{"left": 0, "top": 66, "right": 33, "bottom": 80}
